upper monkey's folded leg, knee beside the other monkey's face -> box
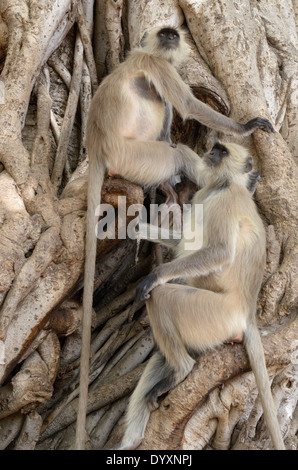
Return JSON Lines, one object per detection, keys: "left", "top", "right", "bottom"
{"left": 108, "top": 139, "right": 202, "bottom": 186}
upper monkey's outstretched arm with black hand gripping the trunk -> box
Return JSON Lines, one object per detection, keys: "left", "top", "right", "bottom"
{"left": 144, "top": 58, "right": 274, "bottom": 136}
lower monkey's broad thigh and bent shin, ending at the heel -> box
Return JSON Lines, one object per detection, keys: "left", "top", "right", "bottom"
{"left": 146, "top": 284, "right": 246, "bottom": 362}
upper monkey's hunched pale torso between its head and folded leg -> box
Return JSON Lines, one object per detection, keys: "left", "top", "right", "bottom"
{"left": 88, "top": 51, "right": 169, "bottom": 143}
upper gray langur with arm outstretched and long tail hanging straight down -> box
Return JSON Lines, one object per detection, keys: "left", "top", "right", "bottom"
{"left": 76, "top": 27, "right": 273, "bottom": 449}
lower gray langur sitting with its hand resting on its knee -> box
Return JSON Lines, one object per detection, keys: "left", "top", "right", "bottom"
{"left": 118, "top": 142, "right": 284, "bottom": 449}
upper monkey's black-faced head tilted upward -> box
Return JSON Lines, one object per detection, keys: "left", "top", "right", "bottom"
{"left": 141, "top": 26, "right": 188, "bottom": 66}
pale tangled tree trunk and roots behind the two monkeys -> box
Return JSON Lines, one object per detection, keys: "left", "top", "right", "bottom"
{"left": 0, "top": 0, "right": 298, "bottom": 450}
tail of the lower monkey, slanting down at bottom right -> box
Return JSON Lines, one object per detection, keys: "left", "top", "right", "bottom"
{"left": 244, "top": 324, "right": 285, "bottom": 450}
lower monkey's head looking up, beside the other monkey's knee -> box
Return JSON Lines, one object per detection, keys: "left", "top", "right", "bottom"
{"left": 203, "top": 142, "right": 257, "bottom": 189}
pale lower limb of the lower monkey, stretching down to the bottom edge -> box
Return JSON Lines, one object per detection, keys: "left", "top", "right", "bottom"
{"left": 119, "top": 352, "right": 173, "bottom": 449}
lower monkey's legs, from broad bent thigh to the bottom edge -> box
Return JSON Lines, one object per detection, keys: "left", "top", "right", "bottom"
{"left": 120, "top": 284, "right": 245, "bottom": 449}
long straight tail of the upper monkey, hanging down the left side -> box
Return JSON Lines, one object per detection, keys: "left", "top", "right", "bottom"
{"left": 75, "top": 152, "right": 105, "bottom": 450}
